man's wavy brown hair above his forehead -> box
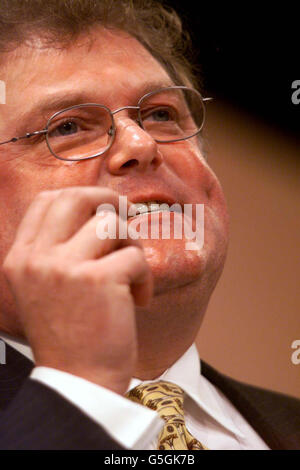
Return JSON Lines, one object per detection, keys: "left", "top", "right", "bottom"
{"left": 0, "top": 0, "right": 200, "bottom": 87}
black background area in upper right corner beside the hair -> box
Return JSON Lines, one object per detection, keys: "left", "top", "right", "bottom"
{"left": 164, "top": 0, "right": 300, "bottom": 141}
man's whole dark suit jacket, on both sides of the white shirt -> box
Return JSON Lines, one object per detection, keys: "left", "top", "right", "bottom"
{"left": 0, "top": 345, "right": 300, "bottom": 450}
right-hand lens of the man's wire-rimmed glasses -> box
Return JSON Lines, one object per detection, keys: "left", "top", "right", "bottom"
{"left": 140, "top": 87, "right": 204, "bottom": 142}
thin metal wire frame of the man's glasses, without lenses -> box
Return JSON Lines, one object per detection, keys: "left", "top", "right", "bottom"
{"left": 0, "top": 85, "right": 213, "bottom": 162}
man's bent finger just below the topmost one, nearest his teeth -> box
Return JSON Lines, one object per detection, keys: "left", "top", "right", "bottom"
{"left": 63, "top": 211, "right": 142, "bottom": 261}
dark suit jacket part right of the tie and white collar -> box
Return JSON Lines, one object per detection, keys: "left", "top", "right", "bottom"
{"left": 201, "top": 361, "right": 300, "bottom": 450}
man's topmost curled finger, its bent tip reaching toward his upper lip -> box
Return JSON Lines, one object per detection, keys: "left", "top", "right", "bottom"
{"left": 34, "top": 187, "right": 130, "bottom": 246}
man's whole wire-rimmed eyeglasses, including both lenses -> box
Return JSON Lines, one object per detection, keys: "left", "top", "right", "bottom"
{"left": 0, "top": 86, "right": 212, "bottom": 161}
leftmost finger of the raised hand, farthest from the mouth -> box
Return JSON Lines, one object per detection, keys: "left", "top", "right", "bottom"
{"left": 16, "top": 189, "right": 61, "bottom": 244}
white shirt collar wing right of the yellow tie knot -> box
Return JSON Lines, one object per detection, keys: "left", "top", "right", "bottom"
{"left": 129, "top": 344, "right": 243, "bottom": 437}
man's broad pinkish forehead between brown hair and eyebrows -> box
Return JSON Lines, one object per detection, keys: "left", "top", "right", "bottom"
{"left": 0, "top": 28, "right": 172, "bottom": 106}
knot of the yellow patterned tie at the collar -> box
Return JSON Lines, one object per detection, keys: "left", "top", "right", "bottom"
{"left": 127, "top": 381, "right": 184, "bottom": 424}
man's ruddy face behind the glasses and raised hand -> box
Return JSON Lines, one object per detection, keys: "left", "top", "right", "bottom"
{"left": 0, "top": 29, "right": 227, "bottom": 330}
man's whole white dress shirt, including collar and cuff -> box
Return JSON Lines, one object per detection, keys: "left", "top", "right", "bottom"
{"left": 1, "top": 334, "right": 269, "bottom": 450}
